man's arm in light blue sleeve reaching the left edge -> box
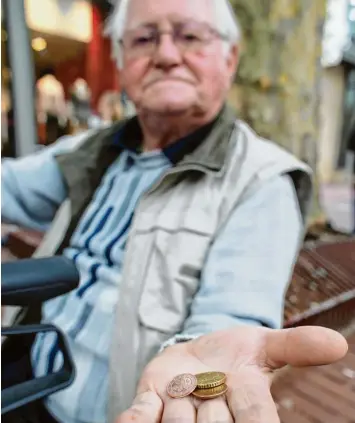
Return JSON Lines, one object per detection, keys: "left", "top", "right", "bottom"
{"left": 1, "top": 137, "right": 86, "bottom": 231}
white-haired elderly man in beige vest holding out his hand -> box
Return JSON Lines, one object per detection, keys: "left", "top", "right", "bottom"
{"left": 2, "top": 0, "right": 346, "bottom": 423}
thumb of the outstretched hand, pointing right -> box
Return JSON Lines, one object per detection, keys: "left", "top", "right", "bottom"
{"left": 266, "top": 326, "right": 348, "bottom": 368}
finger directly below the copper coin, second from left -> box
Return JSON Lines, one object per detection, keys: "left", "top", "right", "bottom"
{"left": 162, "top": 397, "right": 196, "bottom": 423}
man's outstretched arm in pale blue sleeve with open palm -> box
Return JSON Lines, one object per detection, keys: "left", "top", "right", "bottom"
{"left": 117, "top": 177, "right": 347, "bottom": 423}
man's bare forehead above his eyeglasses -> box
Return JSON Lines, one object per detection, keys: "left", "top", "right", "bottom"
{"left": 125, "top": 0, "right": 215, "bottom": 29}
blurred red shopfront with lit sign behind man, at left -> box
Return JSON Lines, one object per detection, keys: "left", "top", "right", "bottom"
{"left": 1, "top": 0, "right": 132, "bottom": 156}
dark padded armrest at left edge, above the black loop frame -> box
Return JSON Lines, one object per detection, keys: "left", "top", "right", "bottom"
{"left": 1, "top": 256, "right": 80, "bottom": 306}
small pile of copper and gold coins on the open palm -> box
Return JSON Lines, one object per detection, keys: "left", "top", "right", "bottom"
{"left": 167, "top": 372, "right": 228, "bottom": 399}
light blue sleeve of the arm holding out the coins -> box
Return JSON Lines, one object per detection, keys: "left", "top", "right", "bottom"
{"left": 164, "top": 175, "right": 304, "bottom": 346}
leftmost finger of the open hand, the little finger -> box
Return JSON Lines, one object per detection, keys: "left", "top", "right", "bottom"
{"left": 116, "top": 391, "right": 163, "bottom": 423}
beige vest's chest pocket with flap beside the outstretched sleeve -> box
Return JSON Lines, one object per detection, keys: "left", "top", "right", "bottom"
{"left": 139, "top": 225, "right": 211, "bottom": 335}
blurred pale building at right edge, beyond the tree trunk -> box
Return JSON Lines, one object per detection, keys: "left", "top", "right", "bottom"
{"left": 318, "top": 0, "right": 355, "bottom": 182}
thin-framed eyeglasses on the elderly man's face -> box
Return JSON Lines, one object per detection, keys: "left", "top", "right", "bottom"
{"left": 120, "top": 22, "right": 228, "bottom": 57}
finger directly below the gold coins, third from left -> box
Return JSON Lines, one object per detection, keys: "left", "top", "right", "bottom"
{"left": 197, "top": 397, "right": 234, "bottom": 423}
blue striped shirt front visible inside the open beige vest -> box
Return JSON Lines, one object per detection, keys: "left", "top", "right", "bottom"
{"left": 32, "top": 150, "right": 171, "bottom": 423}
